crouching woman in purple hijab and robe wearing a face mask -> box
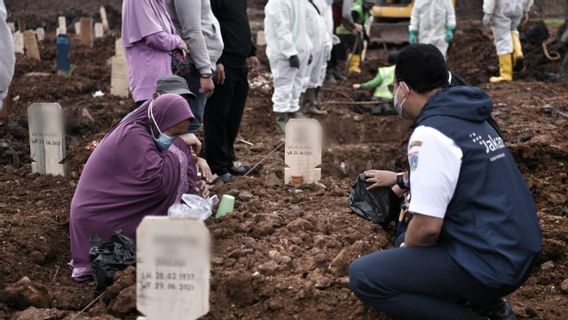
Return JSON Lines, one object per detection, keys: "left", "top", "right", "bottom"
{"left": 69, "top": 94, "right": 197, "bottom": 281}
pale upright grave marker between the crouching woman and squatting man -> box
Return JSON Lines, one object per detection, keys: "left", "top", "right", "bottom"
{"left": 284, "top": 119, "right": 323, "bottom": 184}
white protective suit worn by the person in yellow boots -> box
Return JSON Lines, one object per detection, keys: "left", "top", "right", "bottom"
{"left": 483, "top": 0, "right": 533, "bottom": 56}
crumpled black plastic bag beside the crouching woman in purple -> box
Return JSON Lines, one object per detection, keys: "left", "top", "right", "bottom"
{"left": 89, "top": 230, "right": 136, "bottom": 292}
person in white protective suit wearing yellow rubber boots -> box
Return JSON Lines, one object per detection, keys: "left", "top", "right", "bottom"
{"left": 483, "top": 0, "right": 533, "bottom": 83}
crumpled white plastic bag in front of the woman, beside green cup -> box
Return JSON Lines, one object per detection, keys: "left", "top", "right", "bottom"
{"left": 168, "top": 194, "right": 219, "bottom": 221}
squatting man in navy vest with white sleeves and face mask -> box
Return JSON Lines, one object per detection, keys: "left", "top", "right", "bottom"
{"left": 349, "top": 44, "right": 541, "bottom": 320}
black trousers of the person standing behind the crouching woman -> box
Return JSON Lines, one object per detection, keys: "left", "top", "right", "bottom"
{"left": 203, "top": 66, "right": 249, "bottom": 175}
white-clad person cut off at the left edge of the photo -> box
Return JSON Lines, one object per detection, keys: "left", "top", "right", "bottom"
{"left": 0, "top": 0, "right": 16, "bottom": 111}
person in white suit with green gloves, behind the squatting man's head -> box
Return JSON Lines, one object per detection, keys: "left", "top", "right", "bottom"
{"left": 408, "top": 0, "right": 456, "bottom": 58}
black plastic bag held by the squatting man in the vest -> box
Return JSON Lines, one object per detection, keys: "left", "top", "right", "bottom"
{"left": 349, "top": 174, "right": 401, "bottom": 227}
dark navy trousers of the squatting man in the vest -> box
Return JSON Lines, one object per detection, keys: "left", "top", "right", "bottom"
{"left": 349, "top": 244, "right": 528, "bottom": 320}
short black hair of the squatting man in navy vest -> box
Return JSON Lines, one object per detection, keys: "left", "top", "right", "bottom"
{"left": 395, "top": 44, "right": 448, "bottom": 94}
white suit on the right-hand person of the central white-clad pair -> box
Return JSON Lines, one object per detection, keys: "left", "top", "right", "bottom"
{"left": 300, "top": 0, "right": 333, "bottom": 90}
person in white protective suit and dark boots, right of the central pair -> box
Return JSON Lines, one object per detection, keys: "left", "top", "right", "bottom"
{"left": 300, "top": 0, "right": 333, "bottom": 116}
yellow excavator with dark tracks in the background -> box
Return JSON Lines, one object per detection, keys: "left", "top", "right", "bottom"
{"left": 370, "top": 0, "right": 455, "bottom": 44}
